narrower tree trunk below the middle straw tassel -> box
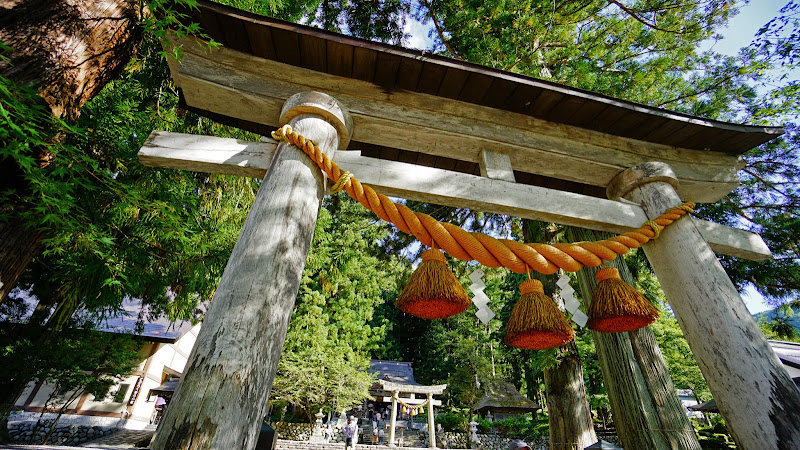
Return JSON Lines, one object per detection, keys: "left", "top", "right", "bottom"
{"left": 544, "top": 340, "right": 597, "bottom": 450}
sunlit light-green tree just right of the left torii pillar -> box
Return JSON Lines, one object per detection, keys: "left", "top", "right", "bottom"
{"left": 272, "top": 196, "right": 405, "bottom": 418}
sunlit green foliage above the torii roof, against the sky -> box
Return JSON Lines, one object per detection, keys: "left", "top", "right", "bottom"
{"left": 417, "top": 0, "right": 735, "bottom": 105}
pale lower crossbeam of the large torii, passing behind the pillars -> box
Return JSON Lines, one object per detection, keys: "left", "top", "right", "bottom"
{"left": 139, "top": 131, "right": 772, "bottom": 261}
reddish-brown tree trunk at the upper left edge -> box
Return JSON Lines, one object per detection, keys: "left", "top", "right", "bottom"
{"left": 0, "top": 0, "right": 142, "bottom": 303}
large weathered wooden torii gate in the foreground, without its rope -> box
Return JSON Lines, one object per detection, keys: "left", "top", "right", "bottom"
{"left": 140, "top": 1, "right": 800, "bottom": 449}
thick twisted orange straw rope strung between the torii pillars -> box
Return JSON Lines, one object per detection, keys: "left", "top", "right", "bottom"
{"left": 272, "top": 125, "right": 694, "bottom": 275}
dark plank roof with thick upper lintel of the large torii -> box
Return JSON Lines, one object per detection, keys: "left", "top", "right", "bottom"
{"left": 171, "top": 1, "right": 783, "bottom": 202}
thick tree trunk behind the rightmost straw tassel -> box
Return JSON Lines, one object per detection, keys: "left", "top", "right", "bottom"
{"left": 567, "top": 228, "right": 700, "bottom": 450}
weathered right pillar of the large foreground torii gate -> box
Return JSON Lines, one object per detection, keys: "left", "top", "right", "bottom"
{"left": 621, "top": 163, "right": 800, "bottom": 450}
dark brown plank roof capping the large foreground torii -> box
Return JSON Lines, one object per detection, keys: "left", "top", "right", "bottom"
{"left": 175, "top": 0, "right": 783, "bottom": 154}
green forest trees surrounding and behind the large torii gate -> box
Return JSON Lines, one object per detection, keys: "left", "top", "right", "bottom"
{"left": 0, "top": 0, "right": 800, "bottom": 446}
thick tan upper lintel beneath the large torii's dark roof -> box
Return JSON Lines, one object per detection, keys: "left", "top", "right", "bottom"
{"left": 170, "top": 38, "right": 743, "bottom": 202}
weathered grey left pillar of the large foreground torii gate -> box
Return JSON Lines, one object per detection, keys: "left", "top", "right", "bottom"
{"left": 151, "top": 110, "right": 338, "bottom": 450}
